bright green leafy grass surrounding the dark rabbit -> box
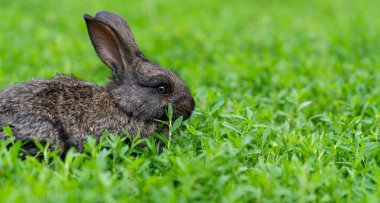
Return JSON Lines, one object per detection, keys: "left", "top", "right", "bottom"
{"left": 0, "top": 0, "right": 380, "bottom": 202}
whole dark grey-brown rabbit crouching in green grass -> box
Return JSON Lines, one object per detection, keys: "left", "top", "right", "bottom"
{"left": 0, "top": 11, "right": 195, "bottom": 154}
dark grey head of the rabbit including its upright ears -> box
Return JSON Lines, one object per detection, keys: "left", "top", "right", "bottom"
{"left": 84, "top": 11, "right": 195, "bottom": 121}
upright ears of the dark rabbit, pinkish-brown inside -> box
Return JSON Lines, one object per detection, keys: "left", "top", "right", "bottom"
{"left": 84, "top": 11, "right": 139, "bottom": 81}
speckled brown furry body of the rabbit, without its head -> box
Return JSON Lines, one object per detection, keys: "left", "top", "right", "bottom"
{"left": 0, "top": 76, "right": 157, "bottom": 151}
